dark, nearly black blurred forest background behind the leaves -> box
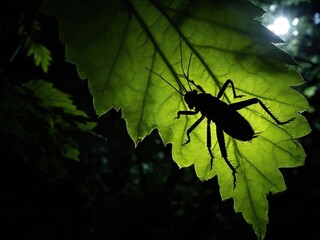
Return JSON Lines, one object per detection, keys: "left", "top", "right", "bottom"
{"left": 0, "top": 0, "right": 320, "bottom": 240}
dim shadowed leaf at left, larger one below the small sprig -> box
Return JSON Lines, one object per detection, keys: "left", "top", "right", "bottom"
{"left": 24, "top": 80, "right": 96, "bottom": 161}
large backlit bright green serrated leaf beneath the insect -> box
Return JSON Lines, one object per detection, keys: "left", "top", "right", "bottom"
{"left": 42, "top": 0, "right": 310, "bottom": 239}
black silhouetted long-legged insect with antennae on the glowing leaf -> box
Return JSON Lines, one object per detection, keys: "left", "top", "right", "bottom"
{"left": 147, "top": 46, "right": 294, "bottom": 188}
